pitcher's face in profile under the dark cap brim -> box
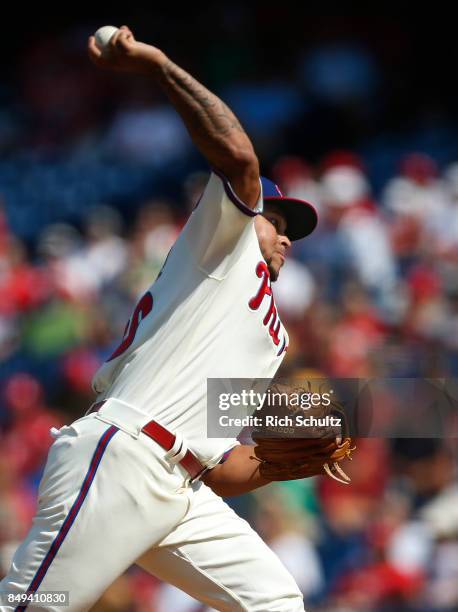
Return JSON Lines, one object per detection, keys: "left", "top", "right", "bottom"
{"left": 255, "top": 204, "right": 291, "bottom": 282}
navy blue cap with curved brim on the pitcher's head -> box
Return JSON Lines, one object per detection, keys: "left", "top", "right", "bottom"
{"left": 261, "top": 176, "right": 318, "bottom": 240}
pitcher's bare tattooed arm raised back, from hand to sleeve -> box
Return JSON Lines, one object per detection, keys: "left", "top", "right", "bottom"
{"left": 88, "top": 26, "right": 259, "bottom": 207}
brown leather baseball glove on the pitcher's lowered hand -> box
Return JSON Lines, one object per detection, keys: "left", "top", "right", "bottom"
{"left": 252, "top": 381, "right": 356, "bottom": 484}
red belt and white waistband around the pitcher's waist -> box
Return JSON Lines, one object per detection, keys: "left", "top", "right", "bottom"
{"left": 86, "top": 398, "right": 210, "bottom": 482}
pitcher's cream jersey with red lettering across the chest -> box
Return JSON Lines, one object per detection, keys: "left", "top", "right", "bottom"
{"left": 93, "top": 172, "right": 288, "bottom": 465}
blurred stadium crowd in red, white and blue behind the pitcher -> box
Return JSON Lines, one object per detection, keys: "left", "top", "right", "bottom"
{"left": 0, "top": 9, "right": 458, "bottom": 612}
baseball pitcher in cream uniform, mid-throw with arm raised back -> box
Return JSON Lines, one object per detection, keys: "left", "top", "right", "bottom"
{"left": 0, "top": 26, "right": 317, "bottom": 612}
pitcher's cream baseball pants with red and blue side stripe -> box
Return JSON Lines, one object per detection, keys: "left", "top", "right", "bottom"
{"left": 0, "top": 414, "right": 304, "bottom": 612}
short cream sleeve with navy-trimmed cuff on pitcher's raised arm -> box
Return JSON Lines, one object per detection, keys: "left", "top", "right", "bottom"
{"left": 182, "top": 170, "right": 263, "bottom": 279}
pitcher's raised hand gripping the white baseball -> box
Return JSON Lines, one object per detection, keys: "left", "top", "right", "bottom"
{"left": 88, "top": 25, "right": 167, "bottom": 74}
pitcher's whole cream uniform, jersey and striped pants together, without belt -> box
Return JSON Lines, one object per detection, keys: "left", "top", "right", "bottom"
{"left": 0, "top": 174, "right": 304, "bottom": 612}
